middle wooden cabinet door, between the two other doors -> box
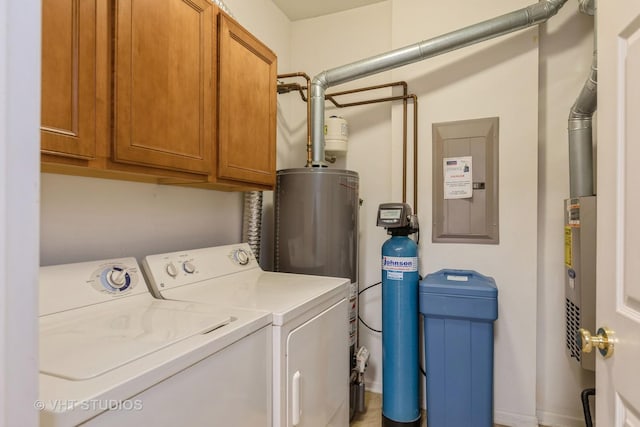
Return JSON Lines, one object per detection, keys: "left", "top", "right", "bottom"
{"left": 113, "top": 0, "right": 215, "bottom": 174}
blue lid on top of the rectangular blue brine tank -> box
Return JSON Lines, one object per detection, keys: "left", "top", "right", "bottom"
{"left": 419, "top": 269, "right": 498, "bottom": 298}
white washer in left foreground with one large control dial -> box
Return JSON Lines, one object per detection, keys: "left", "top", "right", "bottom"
{"left": 39, "top": 258, "right": 272, "bottom": 427}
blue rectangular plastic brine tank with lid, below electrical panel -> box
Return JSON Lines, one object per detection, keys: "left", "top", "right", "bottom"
{"left": 419, "top": 270, "right": 498, "bottom": 427}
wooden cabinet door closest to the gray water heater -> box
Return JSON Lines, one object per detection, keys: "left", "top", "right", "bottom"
{"left": 217, "top": 13, "right": 277, "bottom": 186}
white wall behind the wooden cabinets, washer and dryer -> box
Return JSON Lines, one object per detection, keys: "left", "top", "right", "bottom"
{"left": 40, "top": 0, "right": 290, "bottom": 265}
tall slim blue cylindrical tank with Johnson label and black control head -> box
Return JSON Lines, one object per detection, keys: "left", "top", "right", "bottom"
{"left": 378, "top": 203, "right": 420, "bottom": 427}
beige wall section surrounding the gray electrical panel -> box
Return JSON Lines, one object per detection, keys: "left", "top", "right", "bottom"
{"left": 393, "top": 0, "right": 538, "bottom": 426}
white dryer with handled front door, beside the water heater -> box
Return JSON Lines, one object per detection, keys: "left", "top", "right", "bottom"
{"left": 142, "top": 244, "right": 349, "bottom": 427}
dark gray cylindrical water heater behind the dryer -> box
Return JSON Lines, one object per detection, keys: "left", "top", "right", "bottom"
{"left": 274, "top": 168, "right": 359, "bottom": 342}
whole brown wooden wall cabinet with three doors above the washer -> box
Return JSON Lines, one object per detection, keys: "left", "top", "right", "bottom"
{"left": 41, "top": 0, "right": 277, "bottom": 191}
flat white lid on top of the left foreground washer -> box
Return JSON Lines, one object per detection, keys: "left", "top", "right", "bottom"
{"left": 40, "top": 295, "right": 231, "bottom": 380}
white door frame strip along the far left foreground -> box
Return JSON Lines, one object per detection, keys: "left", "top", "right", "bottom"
{"left": 0, "top": 0, "right": 40, "bottom": 427}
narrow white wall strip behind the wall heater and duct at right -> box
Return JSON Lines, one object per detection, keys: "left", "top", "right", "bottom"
{"left": 537, "top": 2, "right": 597, "bottom": 427}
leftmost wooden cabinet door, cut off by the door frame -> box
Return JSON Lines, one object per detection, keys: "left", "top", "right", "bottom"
{"left": 40, "top": 0, "right": 96, "bottom": 159}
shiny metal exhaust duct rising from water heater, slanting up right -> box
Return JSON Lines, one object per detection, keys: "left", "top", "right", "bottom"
{"left": 311, "top": 0, "right": 567, "bottom": 167}
